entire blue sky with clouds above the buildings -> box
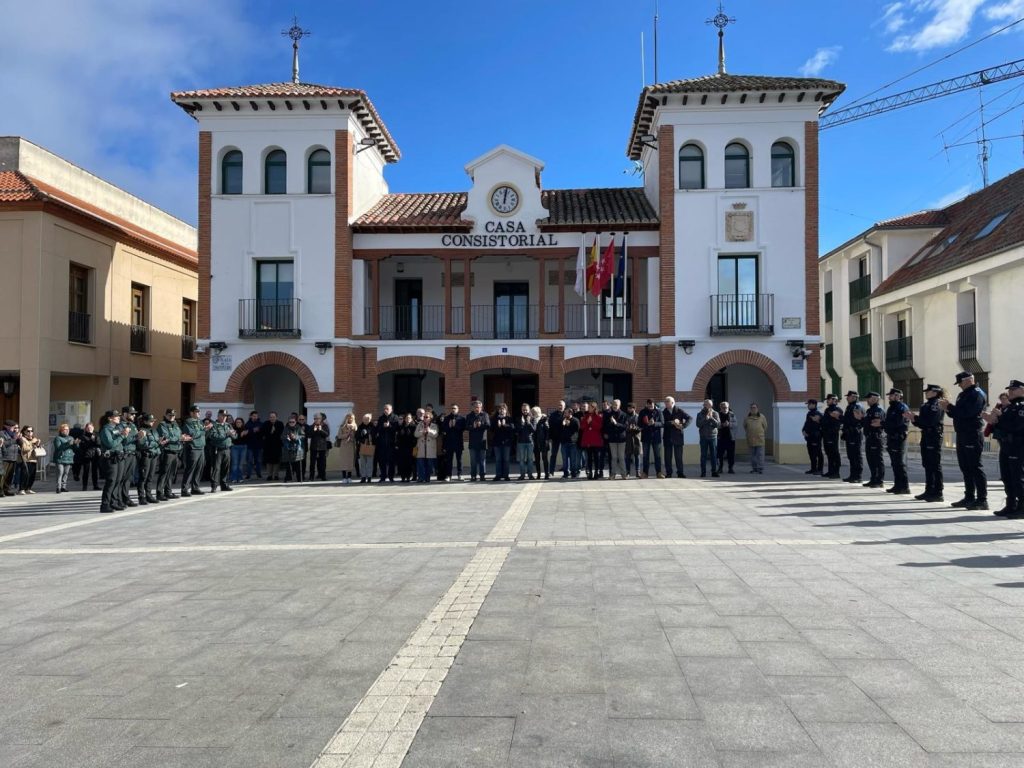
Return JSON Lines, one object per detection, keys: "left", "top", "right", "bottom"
{"left": 0, "top": 0, "right": 1024, "bottom": 250}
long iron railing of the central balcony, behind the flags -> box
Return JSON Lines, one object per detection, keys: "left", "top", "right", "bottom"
{"left": 365, "top": 301, "right": 648, "bottom": 341}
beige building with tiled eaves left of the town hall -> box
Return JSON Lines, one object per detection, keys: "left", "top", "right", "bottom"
{"left": 0, "top": 136, "right": 198, "bottom": 436}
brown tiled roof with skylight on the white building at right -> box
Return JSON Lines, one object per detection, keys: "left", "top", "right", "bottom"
{"left": 871, "top": 170, "right": 1024, "bottom": 296}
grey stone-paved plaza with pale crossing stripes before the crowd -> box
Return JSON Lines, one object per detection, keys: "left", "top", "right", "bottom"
{"left": 0, "top": 466, "right": 1024, "bottom": 768}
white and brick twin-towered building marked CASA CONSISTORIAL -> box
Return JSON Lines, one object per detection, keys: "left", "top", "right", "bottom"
{"left": 172, "top": 66, "right": 844, "bottom": 461}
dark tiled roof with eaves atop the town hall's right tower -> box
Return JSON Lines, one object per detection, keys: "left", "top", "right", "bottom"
{"left": 626, "top": 74, "right": 846, "bottom": 160}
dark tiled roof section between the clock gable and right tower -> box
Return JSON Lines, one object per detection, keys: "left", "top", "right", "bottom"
{"left": 537, "top": 186, "right": 658, "bottom": 229}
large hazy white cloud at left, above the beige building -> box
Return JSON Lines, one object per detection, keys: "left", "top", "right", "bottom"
{"left": 0, "top": 0, "right": 264, "bottom": 221}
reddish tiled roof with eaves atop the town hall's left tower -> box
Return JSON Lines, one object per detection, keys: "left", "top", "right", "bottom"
{"left": 171, "top": 82, "right": 401, "bottom": 163}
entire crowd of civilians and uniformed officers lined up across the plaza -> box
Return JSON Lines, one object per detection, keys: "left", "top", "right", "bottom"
{"left": 0, "top": 372, "right": 1024, "bottom": 519}
